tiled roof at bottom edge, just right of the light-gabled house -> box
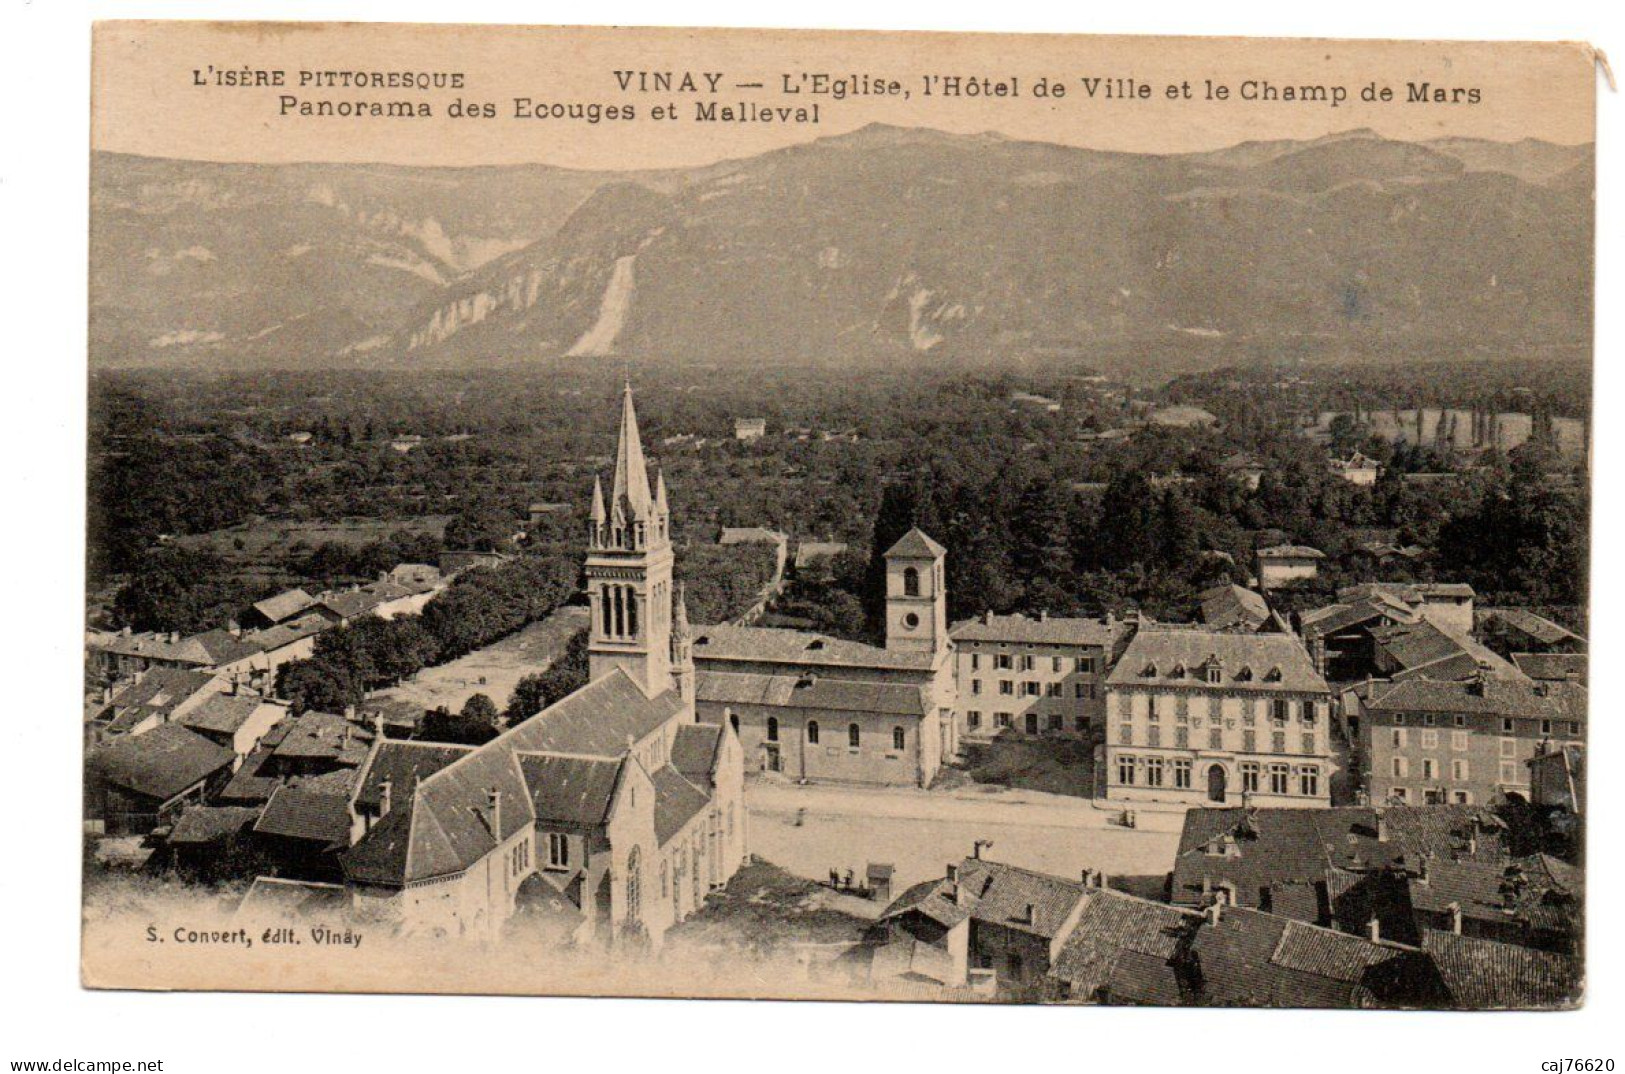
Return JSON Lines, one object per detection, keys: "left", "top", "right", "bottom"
{"left": 1050, "top": 889, "right": 1201, "bottom": 1006}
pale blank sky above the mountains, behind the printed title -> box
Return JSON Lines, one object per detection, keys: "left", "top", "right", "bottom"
{"left": 93, "top": 23, "right": 1596, "bottom": 169}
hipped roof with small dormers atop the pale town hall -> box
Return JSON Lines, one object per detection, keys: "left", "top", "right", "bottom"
{"left": 1107, "top": 627, "right": 1329, "bottom": 694}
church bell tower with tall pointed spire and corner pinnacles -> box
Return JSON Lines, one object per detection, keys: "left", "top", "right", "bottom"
{"left": 587, "top": 382, "right": 673, "bottom": 697}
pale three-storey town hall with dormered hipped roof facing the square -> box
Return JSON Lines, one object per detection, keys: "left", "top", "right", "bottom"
{"left": 1102, "top": 624, "right": 1336, "bottom": 806}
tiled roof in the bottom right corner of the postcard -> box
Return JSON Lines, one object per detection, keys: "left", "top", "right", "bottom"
{"left": 1422, "top": 931, "right": 1581, "bottom": 1011}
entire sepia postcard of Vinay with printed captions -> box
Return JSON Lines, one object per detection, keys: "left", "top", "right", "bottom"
{"left": 57, "top": 10, "right": 1612, "bottom": 1039}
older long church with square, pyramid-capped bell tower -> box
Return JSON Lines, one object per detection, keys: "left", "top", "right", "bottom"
{"left": 694, "top": 530, "right": 959, "bottom": 786}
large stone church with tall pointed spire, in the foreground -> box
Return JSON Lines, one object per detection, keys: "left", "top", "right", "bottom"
{"left": 341, "top": 385, "right": 748, "bottom": 947}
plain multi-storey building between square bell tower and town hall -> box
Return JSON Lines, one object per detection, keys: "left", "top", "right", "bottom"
{"left": 949, "top": 611, "right": 1131, "bottom": 738}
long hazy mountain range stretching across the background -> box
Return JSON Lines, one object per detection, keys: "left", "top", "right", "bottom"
{"left": 91, "top": 127, "right": 1594, "bottom": 378}
